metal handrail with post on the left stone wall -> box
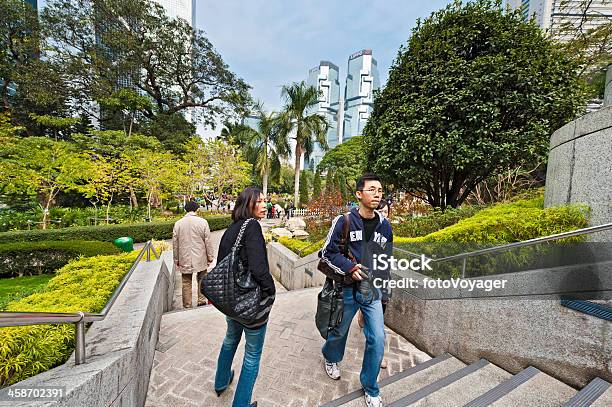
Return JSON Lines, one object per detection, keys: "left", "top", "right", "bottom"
{"left": 0, "top": 240, "right": 160, "bottom": 365}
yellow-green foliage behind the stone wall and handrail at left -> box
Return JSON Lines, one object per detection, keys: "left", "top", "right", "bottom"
{"left": 0, "top": 252, "right": 138, "bottom": 386}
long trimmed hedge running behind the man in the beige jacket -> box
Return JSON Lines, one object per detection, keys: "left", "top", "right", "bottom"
{"left": 0, "top": 216, "right": 232, "bottom": 243}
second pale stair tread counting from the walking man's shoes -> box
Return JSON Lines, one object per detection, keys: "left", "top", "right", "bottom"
{"left": 390, "top": 359, "right": 511, "bottom": 407}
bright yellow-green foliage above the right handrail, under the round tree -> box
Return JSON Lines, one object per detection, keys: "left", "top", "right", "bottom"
{"left": 394, "top": 197, "right": 588, "bottom": 244}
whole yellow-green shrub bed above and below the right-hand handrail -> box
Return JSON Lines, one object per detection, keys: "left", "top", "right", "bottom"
{"left": 394, "top": 196, "right": 588, "bottom": 278}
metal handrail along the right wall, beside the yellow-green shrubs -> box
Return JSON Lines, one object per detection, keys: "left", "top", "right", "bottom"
{"left": 393, "top": 223, "right": 612, "bottom": 276}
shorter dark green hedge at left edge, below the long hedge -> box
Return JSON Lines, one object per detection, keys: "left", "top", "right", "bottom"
{"left": 0, "top": 240, "right": 119, "bottom": 278}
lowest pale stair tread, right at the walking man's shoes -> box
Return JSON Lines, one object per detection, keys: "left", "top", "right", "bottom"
{"left": 321, "top": 353, "right": 465, "bottom": 407}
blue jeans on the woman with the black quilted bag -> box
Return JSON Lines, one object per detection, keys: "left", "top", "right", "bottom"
{"left": 215, "top": 317, "right": 267, "bottom": 407}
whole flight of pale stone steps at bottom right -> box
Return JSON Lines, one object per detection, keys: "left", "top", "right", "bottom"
{"left": 321, "top": 353, "right": 612, "bottom": 407}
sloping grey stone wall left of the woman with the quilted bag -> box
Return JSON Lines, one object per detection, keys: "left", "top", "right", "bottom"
{"left": 0, "top": 252, "right": 174, "bottom": 407}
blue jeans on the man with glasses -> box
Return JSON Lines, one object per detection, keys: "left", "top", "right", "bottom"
{"left": 323, "top": 287, "right": 385, "bottom": 397}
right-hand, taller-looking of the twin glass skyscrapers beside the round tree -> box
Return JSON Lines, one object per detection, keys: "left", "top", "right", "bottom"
{"left": 342, "top": 49, "right": 380, "bottom": 141}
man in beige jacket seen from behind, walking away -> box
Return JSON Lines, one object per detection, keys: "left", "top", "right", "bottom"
{"left": 172, "top": 201, "right": 213, "bottom": 308}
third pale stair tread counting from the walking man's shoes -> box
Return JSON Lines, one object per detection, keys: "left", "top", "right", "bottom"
{"left": 491, "top": 372, "right": 576, "bottom": 407}
